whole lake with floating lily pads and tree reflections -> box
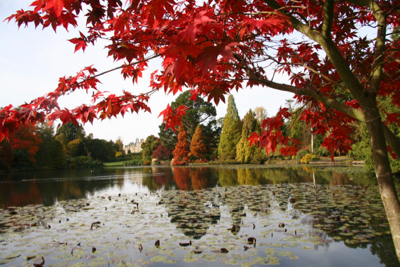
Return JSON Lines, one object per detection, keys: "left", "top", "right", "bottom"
{"left": 0, "top": 166, "right": 399, "bottom": 266}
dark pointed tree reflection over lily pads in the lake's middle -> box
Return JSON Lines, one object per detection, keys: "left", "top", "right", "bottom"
{"left": 160, "top": 190, "right": 221, "bottom": 239}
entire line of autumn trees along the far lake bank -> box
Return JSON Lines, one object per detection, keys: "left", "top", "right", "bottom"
{"left": 0, "top": 91, "right": 400, "bottom": 172}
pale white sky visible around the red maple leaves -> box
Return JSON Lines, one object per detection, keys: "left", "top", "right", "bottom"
{"left": 0, "top": 0, "right": 293, "bottom": 145}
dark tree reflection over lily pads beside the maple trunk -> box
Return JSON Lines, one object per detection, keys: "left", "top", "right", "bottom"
{"left": 292, "top": 182, "right": 398, "bottom": 266}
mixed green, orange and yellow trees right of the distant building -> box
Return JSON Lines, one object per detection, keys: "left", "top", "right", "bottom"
{"left": 142, "top": 92, "right": 400, "bottom": 172}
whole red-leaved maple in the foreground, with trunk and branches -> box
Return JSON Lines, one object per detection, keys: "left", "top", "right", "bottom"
{"left": 0, "top": 0, "right": 400, "bottom": 257}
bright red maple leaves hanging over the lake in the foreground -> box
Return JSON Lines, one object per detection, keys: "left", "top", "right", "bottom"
{"left": 0, "top": 0, "right": 400, "bottom": 164}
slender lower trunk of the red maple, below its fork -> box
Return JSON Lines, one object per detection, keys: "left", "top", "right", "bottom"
{"left": 364, "top": 100, "right": 400, "bottom": 261}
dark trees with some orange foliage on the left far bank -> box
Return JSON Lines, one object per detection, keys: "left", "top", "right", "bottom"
{"left": 0, "top": 123, "right": 123, "bottom": 171}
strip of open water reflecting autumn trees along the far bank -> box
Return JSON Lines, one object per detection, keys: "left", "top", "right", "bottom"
{"left": 0, "top": 167, "right": 376, "bottom": 208}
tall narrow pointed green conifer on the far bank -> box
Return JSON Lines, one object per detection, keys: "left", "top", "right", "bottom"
{"left": 218, "top": 95, "right": 242, "bottom": 160}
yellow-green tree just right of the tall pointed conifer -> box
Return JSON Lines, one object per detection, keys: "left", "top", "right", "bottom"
{"left": 236, "top": 109, "right": 263, "bottom": 163}
